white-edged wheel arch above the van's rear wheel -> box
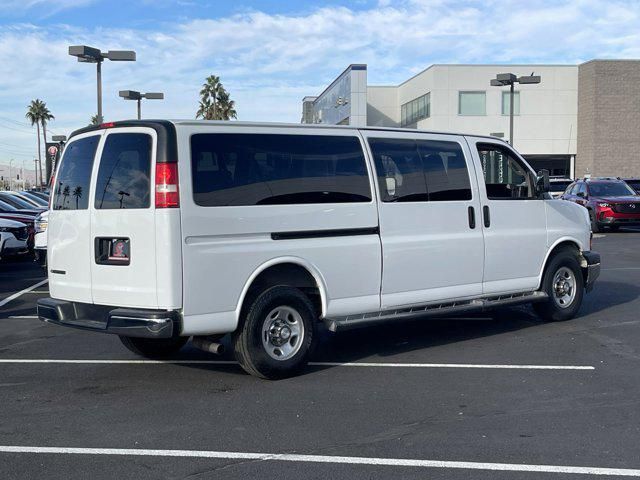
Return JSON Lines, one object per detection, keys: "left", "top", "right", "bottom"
{"left": 235, "top": 256, "right": 328, "bottom": 325}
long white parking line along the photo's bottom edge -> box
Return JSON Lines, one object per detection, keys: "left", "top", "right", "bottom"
{"left": 0, "top": 445, "right": 640, "bottom": 477}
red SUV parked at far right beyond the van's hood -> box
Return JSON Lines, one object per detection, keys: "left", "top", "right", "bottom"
{"left": 560, "top": 178, "right": 640, "bottom": 232}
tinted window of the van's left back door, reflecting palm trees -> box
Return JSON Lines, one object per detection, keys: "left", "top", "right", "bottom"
{"left": 51, "top": 135, "right": 100, "bottom": 210}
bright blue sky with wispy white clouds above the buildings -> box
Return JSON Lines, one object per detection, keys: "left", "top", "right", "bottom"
{"left": 0, "top": 0, "right": 640, "bottom": 164}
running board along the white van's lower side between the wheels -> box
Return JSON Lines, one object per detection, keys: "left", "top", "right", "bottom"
{"left": 324, "top": 291, "right": 549, "bottom": 332}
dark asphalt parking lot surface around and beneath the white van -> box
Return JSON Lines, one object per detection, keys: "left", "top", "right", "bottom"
{"left": 0, "top": 231, "right": 640, "bottom": 480}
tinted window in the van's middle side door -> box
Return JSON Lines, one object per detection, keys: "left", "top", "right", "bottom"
{"left": 369, "top": 138, "right": 471, "bottom": 202}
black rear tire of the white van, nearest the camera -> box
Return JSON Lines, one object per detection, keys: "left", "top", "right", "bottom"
{"left": 232, "top": 286, "right": 318, "bottom": 380}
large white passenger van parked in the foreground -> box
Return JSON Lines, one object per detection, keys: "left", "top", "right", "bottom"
{"left": 38, "top": 121, "right": 600, "bottom": 378}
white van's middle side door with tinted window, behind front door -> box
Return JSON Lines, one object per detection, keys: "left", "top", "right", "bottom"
{"left": 363, "top": 131, "right": 484, "bottom": 309}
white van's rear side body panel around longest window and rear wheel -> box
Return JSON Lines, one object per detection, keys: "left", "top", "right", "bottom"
{"left": 176, "top": 124, "right": 382, "bottom": 334}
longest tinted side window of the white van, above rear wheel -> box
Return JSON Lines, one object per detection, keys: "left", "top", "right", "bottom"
{"left": 191, "top": 133, "right": 371, "bottom": 207}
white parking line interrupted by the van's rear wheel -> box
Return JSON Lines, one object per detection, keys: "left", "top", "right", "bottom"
{"left": 0, "top": 358, "right": 595, "bottom": 370}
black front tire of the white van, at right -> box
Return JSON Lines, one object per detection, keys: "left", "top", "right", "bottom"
{"left": 533, "top": 248, "right": 584, "bottom": 322}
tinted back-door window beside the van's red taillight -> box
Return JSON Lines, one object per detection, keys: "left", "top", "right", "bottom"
{"left": 95, "top": 133, "right": 152, "bottom": 209}
